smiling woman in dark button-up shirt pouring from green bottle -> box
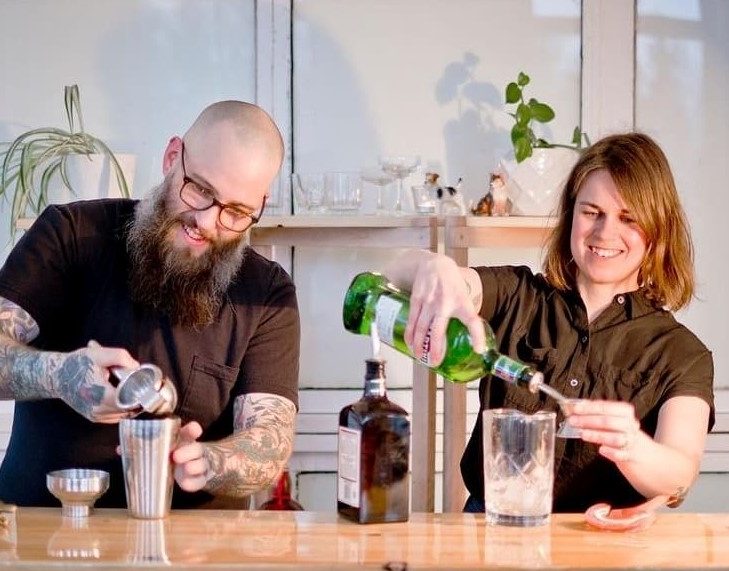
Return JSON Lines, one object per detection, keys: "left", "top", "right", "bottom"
{"left": 385, "top": 133, "right": 714, "bottom": 511}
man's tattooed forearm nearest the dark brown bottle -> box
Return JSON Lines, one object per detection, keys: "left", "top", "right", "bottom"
{"left": 199, "top": 393, "right": 296, "bottom": 497}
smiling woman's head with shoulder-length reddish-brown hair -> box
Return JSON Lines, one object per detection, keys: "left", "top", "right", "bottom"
{"left": 545, "top": 133, "right": 694, "bottom": 311}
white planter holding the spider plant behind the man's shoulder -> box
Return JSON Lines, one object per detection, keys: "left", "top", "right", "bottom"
{"left": 48, "top": 153, "right": 136, "bottom": 204}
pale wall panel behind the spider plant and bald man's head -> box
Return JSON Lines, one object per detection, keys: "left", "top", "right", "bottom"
{"left": 0, "top": 0, "right": 256, "bottom": 260}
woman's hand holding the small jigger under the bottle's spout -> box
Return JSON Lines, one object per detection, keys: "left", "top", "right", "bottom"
{"left": 567, "top": 400, "right": 650, "bottom": 462}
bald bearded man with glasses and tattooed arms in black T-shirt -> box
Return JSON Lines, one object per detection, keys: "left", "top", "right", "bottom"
{"left": 0, "top": 101, "right": 299, "bottom": 508}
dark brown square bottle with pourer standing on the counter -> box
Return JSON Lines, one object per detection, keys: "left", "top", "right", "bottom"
{"left": 337, "top": 359, "right": 410, "bottom": 523}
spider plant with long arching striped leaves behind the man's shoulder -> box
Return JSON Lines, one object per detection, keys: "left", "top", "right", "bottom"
{"left": 0, "top": 85, "right": 129, "bottom": 237}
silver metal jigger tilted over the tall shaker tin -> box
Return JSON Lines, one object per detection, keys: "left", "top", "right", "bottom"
{"left": 111, "top": 363, "right": 177, "bottom": 415}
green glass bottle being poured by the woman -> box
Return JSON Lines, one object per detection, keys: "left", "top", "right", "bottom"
{"left": 343, "top": 272, "right": 544, "bottom": 392}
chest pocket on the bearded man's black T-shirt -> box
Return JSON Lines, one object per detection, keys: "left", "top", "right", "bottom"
{"left": 180, "top": 355, "right": 238, "bottom": 430}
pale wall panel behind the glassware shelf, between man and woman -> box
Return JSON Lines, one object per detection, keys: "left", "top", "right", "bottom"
{"left": 293, "top": 0, "right": 580, "bottom": 394}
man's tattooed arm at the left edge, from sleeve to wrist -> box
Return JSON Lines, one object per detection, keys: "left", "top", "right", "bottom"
{"left": 0, "top": 297, "right": 104, "bottom": 418}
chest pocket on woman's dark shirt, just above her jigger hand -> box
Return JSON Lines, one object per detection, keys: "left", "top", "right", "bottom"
{"left": 580, "top": 363, "right": 654, "bottom": 418}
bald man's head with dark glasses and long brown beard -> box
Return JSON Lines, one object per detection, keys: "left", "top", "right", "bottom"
{"left": 128, "top": 101, "right": 284, "bottom": 328}
